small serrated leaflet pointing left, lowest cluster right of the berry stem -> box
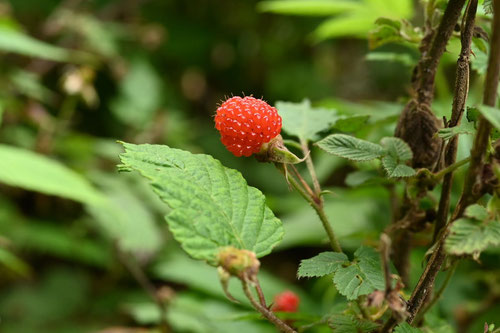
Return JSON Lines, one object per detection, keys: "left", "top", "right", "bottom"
{"left": 297, "top": 252, "right": 349, "bottom": 278}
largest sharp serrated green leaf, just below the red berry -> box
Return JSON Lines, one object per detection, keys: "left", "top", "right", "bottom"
{"left": 116, "top": 143, "right": 283, "bottom": 265}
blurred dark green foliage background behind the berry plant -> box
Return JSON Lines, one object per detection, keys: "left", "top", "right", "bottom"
{"left": 0, "top": 0, "right": 500, "bottom": 333}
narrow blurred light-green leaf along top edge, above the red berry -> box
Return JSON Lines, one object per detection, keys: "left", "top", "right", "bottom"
{"left": 257, "top": 0, "right": 362, "bottom": 16}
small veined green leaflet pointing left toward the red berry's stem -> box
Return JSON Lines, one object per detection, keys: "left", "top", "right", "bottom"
{"left": 316, "top": 134, "right": 385, "bottom": 161}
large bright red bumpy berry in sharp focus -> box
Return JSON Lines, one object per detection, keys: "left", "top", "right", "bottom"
{"left": 215, "top": 96, "right": 281, "bottom": 156}
